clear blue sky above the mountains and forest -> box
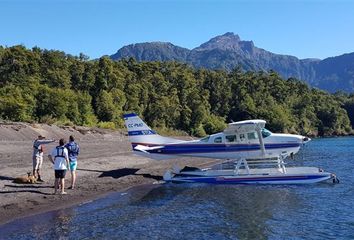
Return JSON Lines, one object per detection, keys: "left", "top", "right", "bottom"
{"left": 0, "top": 0, "right": 354, "bottom": 59}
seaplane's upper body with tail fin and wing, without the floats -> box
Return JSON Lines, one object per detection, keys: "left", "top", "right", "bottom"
{"left": 124, "top": 113, "right": 310, "bottom": 160}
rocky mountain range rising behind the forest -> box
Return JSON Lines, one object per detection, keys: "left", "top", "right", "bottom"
{"left": 111, "top": 32, "right": 354, "bottom": 92}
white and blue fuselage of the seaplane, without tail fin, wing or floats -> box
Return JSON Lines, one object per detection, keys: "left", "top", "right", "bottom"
{"left": 132, "top": 133, "right": 303, "bottom": 159}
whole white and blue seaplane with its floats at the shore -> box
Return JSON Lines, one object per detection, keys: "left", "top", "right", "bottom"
{"left": 123, "top": 113, "right": 338, "bottom": 184}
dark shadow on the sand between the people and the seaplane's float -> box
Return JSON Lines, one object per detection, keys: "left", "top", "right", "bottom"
{"left": 77, "top": 168, "right": 163, "bottom": 181}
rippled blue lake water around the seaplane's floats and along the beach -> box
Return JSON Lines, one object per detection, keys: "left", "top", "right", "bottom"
{"left": 0, "top": 137, "right": 354, "bottom": 240}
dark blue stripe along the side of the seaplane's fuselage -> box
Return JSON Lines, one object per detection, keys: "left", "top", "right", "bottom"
{"left": 132, "top": 143, "right": 300, "bottom": 154}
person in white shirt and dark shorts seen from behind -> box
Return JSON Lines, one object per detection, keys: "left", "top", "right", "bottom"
{"left": 48, "top": 139, "right": 70, "bottom": 194}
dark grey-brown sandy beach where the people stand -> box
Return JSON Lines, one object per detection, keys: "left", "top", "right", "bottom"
{"left": 0, "top": 124, "right": 217, "bottom": 224}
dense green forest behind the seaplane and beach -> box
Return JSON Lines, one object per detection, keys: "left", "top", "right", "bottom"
{"left": 0, "top": 46, "right": 354, "bottom": 136}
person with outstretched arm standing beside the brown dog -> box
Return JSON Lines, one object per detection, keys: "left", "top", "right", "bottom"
{"left": 32, "top": 135, "right": 55, "bottom": 182}
